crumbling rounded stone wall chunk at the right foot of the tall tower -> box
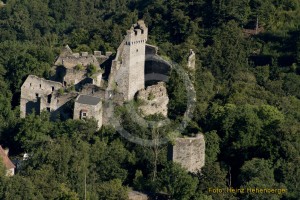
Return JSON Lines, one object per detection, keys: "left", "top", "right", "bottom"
{"left": 137, "top": 82, "right": 169, "bottom": 117}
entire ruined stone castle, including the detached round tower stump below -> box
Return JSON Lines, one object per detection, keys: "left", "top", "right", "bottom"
{"left": 20, "top": 20, "right": 205, "bottom": 172}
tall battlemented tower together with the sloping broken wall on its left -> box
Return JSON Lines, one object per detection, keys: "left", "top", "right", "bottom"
{"left": 109, "top": 20, "right": 148, "bottom": 100}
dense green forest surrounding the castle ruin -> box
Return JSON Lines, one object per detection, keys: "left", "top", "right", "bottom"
{"left": 0, "top": 0, "right": 300, "bottom": 200}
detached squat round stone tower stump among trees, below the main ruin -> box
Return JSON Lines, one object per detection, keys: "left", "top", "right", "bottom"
{"left": 168, "top": 134, "right": 205, "bottom": 172}
